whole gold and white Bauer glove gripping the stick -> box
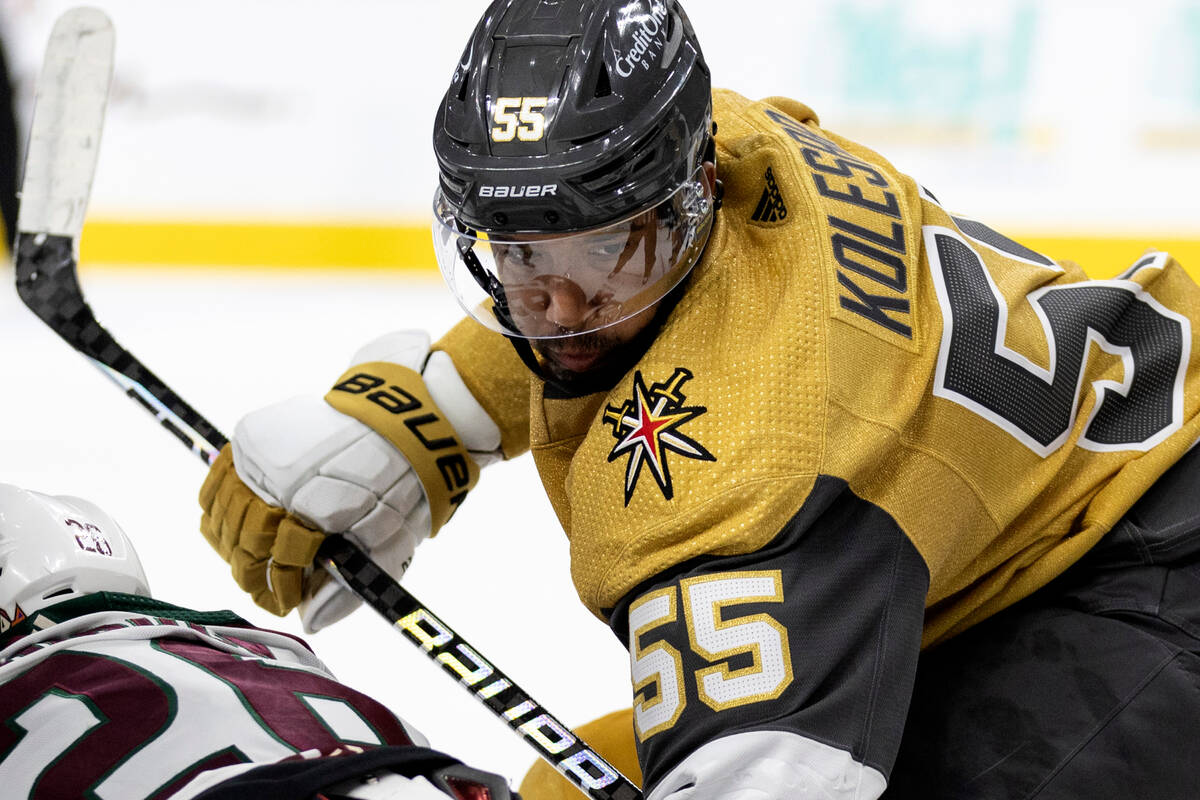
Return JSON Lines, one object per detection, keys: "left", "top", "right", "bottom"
{"left": 200, "top": 331, "right": 500, "bottom": 632}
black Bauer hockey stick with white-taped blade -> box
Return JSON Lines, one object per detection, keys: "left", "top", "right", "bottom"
{"left": 16, "top": 8, "right": 642, "bottom": 800}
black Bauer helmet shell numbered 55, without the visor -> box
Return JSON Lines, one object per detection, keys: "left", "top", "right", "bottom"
{"left": 433, "top": 0, "right": 712, "bottom": 233}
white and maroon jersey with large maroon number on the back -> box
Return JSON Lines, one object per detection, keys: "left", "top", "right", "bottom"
{"left": 0, "top": 593, "right": 425, "bottom": 800}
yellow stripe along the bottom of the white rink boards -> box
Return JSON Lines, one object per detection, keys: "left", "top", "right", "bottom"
{"left": 72, "top": 219, "right": 1200, "bottom": 279}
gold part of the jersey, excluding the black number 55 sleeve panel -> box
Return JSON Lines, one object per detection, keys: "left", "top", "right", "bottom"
{"left": 438, "top": 91, "right": 1200, "bottom": 645}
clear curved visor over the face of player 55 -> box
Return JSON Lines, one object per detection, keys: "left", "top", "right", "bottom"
{"left": 433, "top": 169, "right": 713, "bottom": 339}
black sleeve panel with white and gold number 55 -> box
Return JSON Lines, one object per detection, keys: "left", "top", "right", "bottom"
{"left": 610, "top": 476, "right": 929, "bottom": 786}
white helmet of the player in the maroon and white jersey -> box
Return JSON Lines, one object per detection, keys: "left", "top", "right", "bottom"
{"left": 0, "top": 483, "right": 150, "bottom": 631}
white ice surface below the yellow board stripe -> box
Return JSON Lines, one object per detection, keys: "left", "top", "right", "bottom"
{"left": 0, "top": 267, "right": 629, "bottom": 796}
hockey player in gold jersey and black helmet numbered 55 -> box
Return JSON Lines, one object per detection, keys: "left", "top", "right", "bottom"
{"left": 200, "top": 0, "right": 1200, "bottom": 800}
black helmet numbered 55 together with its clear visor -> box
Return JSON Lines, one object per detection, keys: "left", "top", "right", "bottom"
{"left": 433, "top": 0, "right": 713, "bottom": 338}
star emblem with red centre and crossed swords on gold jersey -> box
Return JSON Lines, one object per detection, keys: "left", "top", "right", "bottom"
{"left": 604, "top": 367, "right": 716, "bottom": 506}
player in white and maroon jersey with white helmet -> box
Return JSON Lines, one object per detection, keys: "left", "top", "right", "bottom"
{"left": 0, "top": 483, "right": 510, "bottom": 800}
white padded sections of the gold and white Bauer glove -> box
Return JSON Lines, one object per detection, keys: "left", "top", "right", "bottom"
{"left": 233, "top": 331, "right": 502, "bottom": 633}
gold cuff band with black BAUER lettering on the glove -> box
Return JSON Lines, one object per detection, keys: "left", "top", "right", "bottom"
{"left": 325, "top": 361, "right": 479, "bottom": 534}
